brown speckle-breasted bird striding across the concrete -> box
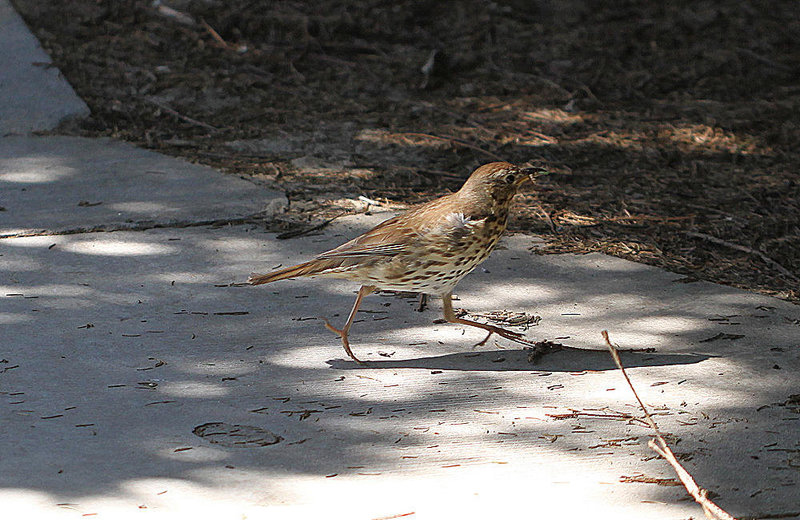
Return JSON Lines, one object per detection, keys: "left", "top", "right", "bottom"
{"left": 248, "top": 162, "right": 547, "bottom": 363}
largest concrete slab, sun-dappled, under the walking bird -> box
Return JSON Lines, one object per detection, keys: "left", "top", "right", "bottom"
{"left": 0, "top": 215, "right": 800, "bottom": 519}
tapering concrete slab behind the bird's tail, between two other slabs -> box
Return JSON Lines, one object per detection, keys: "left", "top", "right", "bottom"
{"left": 0, "top": 136, "right": 286, "bottom": 237}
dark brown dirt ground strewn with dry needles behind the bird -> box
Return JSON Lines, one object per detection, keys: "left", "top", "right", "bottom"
{"left": 12, "top": 0, "right": 800, "bottom": 302}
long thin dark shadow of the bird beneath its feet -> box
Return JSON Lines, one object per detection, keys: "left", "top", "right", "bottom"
{"left": 327, "top": 347, "right": 711, "bottom": 372}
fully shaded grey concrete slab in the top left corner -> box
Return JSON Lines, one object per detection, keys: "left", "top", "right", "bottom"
{"left": 0, "top": 0, "right": 89, "bottom": 136}
